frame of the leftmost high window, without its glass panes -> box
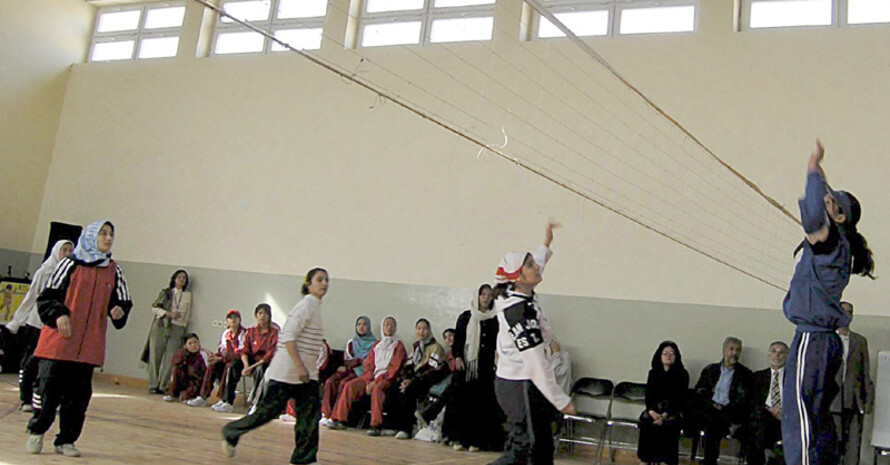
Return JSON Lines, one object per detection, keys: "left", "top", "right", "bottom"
{"left": 87, "top": 0, "right": 187, "bottom": 63}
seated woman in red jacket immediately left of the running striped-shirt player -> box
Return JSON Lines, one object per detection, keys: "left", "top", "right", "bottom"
{"left": 240, "top": 303, "right": 281, "bottom": 406}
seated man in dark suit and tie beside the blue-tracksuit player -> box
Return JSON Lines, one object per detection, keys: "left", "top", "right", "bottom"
{"left": 746, "top": 341, "right": 788, "bottom": 465}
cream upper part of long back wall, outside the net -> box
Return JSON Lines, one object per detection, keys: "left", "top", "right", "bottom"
{"left": 33, "top": 2, "right": 890, "bottom": 315}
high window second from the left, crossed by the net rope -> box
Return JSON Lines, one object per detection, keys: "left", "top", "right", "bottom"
{"left": 213, "top": 0, "right": 328, "bottom": 55}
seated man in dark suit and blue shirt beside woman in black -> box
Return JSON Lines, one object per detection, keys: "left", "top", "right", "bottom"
{"left": 695, "top": 336, "right": 751, "bottom": 465}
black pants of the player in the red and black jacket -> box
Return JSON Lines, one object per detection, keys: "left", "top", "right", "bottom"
{"left": 28, "top": 360, "right": 95, "bottom": 446}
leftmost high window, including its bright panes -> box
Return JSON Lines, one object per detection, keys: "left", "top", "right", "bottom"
{"left": 90, "top": 2, "right": 185, "bottom": 61}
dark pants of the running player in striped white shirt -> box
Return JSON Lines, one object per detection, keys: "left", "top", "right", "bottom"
{"left": 222, "top": 379, "right": 321, "bottom": 463}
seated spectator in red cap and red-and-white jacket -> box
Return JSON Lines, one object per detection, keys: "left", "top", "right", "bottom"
{"left": 186, "top": 310, "right": 246, "bottom": 412}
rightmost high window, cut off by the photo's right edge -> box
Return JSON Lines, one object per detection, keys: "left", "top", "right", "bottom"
{"left": 739, "top": 0, "right": 890, "bottom": 30}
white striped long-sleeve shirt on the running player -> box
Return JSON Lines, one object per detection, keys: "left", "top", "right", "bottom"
{"left": 266, "top": 294, "right": 323, "bottom": 384}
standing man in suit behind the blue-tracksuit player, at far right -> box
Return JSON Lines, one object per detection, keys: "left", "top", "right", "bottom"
{"left": 831, "top": 302, "right": 875, "bottom": 465}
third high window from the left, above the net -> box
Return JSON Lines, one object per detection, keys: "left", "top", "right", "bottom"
{"left": 359, "top": 0, "right": 495, "bottom": 47}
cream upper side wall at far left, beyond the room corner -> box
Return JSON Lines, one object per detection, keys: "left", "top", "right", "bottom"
{"left": 0, "top": 0, "right": 95, "bottom": 254}
